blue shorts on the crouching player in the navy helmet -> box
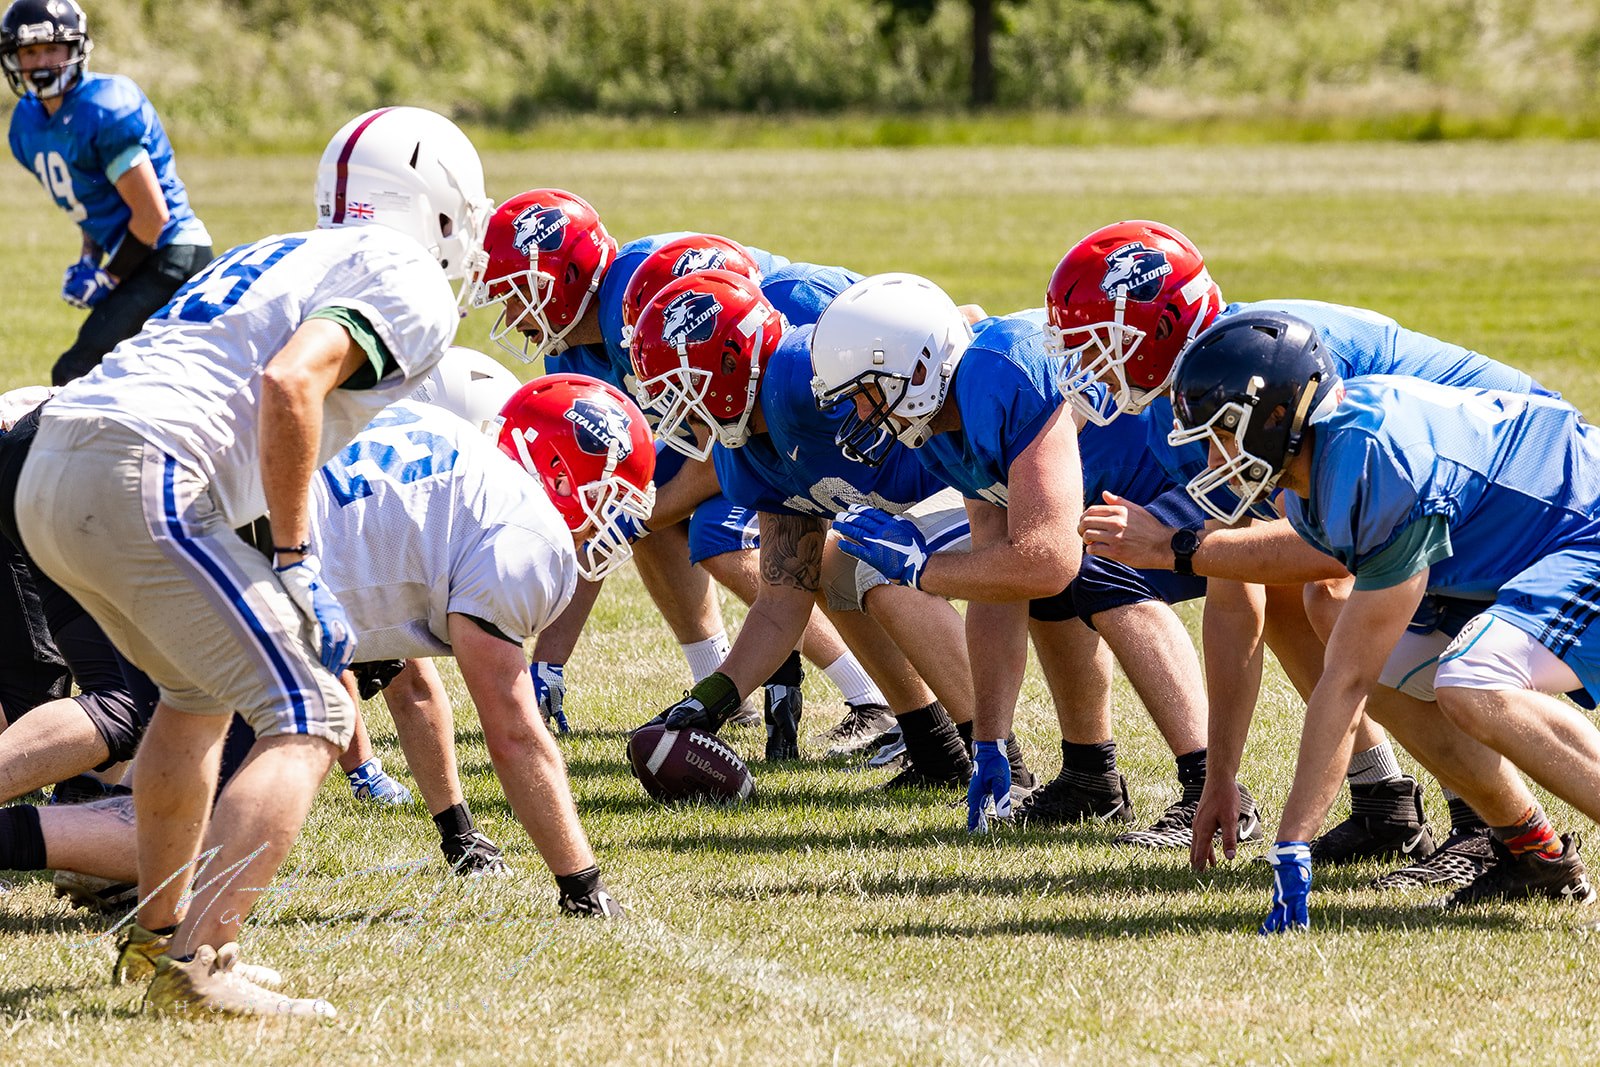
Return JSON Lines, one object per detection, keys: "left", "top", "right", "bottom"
{"left": 1488, "top": 545, "right": 1600, "bottom": 697}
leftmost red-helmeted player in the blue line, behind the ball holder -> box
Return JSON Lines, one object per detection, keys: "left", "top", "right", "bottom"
{"left": 474, "top": 189, "right": 882, "bottom": 742}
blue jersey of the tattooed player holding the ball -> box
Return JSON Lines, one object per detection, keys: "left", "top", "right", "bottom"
{"left": 712, "top": 325, "right": 944, "bottom": 518}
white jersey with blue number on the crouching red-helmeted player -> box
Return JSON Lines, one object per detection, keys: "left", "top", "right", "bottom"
{"left": 312, "top": 400, "right": 578, "bottom": 661}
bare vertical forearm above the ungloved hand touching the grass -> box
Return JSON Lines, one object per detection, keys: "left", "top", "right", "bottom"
{"left": 1200, "top": 579, "right": 1266, "bottom": 777}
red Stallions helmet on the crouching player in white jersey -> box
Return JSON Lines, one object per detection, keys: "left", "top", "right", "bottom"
{"left": 496, "top": 374, "right": 656, "bottom": 582}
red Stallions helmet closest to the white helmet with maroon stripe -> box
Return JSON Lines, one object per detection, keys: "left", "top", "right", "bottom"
{"left": 472, "top": 189, "right": 616, "bottom": 363}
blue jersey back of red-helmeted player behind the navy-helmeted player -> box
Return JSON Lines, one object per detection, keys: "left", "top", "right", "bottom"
{"left": 1222, "top": 301, "right": 1558, "bottom": 397}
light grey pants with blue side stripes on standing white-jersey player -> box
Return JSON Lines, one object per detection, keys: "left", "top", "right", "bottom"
{"left": 16, "top": 408, "right": 355, "bottom": 749}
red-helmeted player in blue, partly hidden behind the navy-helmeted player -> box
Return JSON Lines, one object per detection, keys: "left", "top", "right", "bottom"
{"left": 1046, "top": 221, "right": 1544, "bottom": 885}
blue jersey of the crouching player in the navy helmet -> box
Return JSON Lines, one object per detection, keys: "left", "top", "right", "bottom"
{"left": 1285, "top": 376, "right": 1600, "bottom": 600}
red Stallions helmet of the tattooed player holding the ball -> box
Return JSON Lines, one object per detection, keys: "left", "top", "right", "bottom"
{"left": 630, "top": 270, "right": 784, "bottom": 459}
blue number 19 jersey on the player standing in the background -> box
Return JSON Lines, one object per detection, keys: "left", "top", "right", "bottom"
{"left": 11, "top": 72, "right": 211, "bottom": 254}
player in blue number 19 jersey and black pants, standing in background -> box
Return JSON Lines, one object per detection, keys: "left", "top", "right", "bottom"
{"left": 0, "top": 0, "right": 211, "bottom": 386}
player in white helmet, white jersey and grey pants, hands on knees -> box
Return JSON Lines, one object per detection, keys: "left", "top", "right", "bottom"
{"left": 5, "top": 107, "right": 491, "bottom": 1016}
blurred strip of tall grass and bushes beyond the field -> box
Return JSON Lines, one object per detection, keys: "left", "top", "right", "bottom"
{"left": 50, "top": 0, "right": 1600, "bottom": 142}
